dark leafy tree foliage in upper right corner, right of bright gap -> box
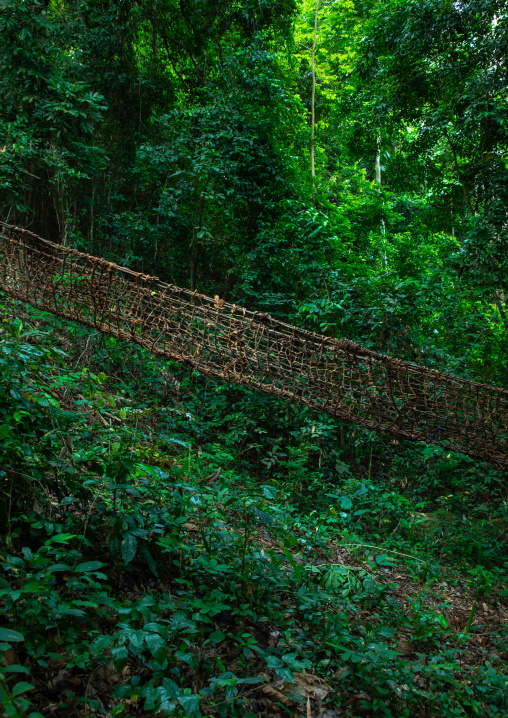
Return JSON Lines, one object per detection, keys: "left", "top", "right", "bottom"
{"left": 359, "top": 0, "right": 508, "bottom": 290}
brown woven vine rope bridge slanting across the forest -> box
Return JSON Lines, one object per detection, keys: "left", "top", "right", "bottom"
{"left": 0, "top": 223, "right": 508, "bottom": 469}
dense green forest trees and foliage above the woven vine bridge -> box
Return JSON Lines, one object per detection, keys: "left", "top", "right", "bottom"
{"left": 0, "top": 0, "right": 508, "bottom": 384}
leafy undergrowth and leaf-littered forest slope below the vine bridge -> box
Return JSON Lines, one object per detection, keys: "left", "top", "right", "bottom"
{"left": 0, "top": 299, "right": 508, "bottom": 718}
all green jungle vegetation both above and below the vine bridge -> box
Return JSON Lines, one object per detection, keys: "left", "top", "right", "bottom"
{"left": 0, "top": 0, "right": 508, "bottom": 718}
